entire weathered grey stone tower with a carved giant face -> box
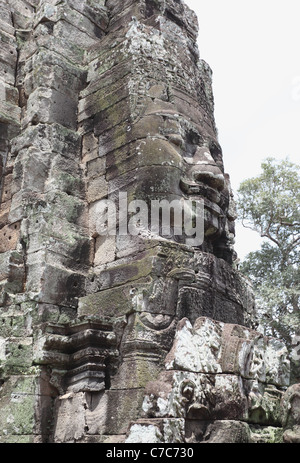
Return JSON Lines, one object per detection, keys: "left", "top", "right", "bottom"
{"left": 0, "top": 0, "right": 297, "bottom": 443}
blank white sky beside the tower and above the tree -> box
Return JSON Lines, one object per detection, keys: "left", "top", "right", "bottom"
{"left": 185, "top": 0, "right": 300, "bottom": 259}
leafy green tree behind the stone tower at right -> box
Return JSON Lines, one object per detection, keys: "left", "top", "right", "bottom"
{"left": 237, "top": 158, "right": 300, "bottom": 382}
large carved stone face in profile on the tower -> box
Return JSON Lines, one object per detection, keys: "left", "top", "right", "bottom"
{"left": 107, "top": 111, "right": 234, "bottom": 260}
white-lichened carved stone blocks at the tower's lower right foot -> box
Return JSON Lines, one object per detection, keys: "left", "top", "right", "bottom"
{"left": 132, "top": 318, "right": 289, "bottom": 439}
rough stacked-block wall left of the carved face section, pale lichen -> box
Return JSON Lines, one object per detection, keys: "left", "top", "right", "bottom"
{"left": 0, "top": 1, "right": 107, "bottom": 442}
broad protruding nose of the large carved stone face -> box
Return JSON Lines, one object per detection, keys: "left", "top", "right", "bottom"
{"left": 191, "top": 148, "right": 225, "bottom": 191}
